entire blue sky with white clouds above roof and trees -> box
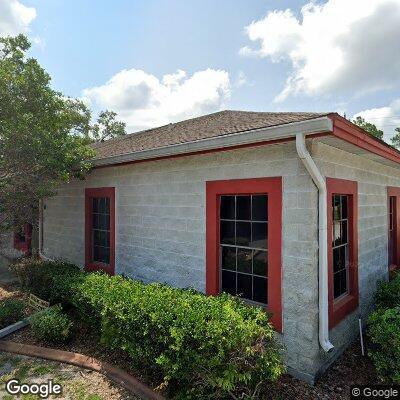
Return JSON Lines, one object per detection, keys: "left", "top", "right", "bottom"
{"left": 0, "top": 0, "right": 400, "bottom": 140}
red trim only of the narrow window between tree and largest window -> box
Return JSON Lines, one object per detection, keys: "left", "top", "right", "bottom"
{"left": 85, "top": 187, "right": 115, "bottom": 275}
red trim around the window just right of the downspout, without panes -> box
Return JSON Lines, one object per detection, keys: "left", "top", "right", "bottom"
{"left": 326, "top": 178, "right": 359, "bottom": 329}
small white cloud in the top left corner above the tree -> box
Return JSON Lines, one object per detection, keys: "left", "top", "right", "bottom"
{"left": 0, "top": 0, "right": 36, "bottom": 36}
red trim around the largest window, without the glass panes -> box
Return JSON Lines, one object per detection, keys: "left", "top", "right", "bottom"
{"left": 206, "top": 177, "right": 282, "bottom": 332}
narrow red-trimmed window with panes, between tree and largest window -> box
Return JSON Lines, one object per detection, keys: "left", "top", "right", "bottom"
{"left": 85, "top": 188, "right": 115, "bottom": 275}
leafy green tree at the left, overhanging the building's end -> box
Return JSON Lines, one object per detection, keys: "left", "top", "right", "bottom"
{"left": 0, "top": 35, "right": 94, "bottom": 230}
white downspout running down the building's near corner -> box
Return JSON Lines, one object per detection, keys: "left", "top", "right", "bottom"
{"left": 296, "top": 133, "right": 333, "bottom": 352}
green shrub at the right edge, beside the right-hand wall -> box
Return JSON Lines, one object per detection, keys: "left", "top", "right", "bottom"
{"left": 368, "top": 274, "right": 400, "bottom": 383}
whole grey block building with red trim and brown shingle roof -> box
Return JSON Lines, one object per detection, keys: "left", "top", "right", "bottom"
{"left": 33, "top": 111, "right": 400, "bottom": 382}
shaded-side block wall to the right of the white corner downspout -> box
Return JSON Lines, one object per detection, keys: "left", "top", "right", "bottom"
{"left": 311, "top": 141, "right": 400, "bottom": 378}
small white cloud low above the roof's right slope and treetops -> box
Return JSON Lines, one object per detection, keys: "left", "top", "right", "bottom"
{"left": 352, "top": 99, "right": 400, "bottom": 142}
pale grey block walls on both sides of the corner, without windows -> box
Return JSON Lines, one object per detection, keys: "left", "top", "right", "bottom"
{"left": 43, "top": 141, "right": 400, "bottom": 381}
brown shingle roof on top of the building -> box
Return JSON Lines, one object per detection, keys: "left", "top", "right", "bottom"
{"left": 93, "top": 110, "right": 328, "bottom": 159}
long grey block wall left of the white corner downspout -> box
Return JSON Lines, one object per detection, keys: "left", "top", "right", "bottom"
{"left": 43, "top": 142, "right": 319, "bottom": 376}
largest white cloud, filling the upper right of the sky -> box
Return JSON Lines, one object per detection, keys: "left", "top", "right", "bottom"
{"left": 240, "top": 0, "right": 400, "bottom": 101}
